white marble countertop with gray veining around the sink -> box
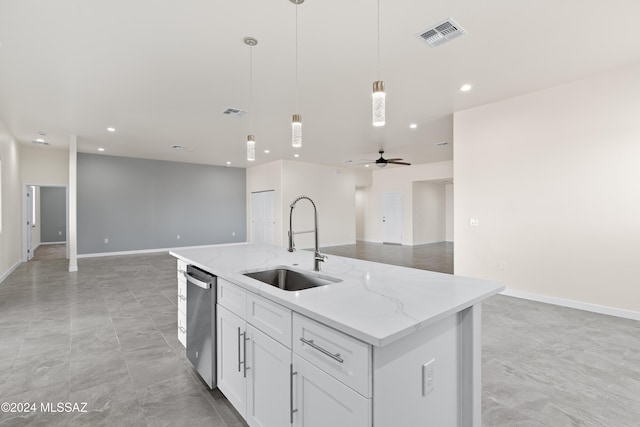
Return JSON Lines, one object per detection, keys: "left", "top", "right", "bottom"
{"left": 170, "top": 244, "right": 504, "bottom": 346}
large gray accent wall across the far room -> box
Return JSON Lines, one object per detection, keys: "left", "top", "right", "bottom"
{"left": 78, "top": 153, "right": 247, "bottom": 254}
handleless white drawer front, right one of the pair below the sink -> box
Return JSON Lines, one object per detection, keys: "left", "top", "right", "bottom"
{"left": 247, "top": 292, "right": 291, "bottom": 348}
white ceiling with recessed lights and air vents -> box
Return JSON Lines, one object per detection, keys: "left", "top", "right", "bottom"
{"left": 0, "top": 0, "right": 640, "bottom": 167}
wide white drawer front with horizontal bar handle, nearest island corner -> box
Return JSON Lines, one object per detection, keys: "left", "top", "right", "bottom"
{"left": 293, "top": 313, "right": 371, "bottom": 398}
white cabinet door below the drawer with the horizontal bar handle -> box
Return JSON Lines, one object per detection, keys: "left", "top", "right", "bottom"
{"left": 293, "top": 354, "right": 371, "bottom": 427}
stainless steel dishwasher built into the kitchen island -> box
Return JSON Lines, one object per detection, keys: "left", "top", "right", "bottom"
{"left": 186, "top": 265, "right": 216, "bottom": 389}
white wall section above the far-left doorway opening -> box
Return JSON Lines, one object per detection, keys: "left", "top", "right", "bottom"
{"left": 21, "top": 146, "right": 69, "bottom": 186}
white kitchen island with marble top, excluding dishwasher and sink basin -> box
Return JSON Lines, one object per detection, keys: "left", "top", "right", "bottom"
{"left": 171, "top": 244, "right": 504, "bottom": 427}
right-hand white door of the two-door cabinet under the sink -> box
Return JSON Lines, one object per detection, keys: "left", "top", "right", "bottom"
{"left": 245, "top": 324, "right": 291, "bottom": 427}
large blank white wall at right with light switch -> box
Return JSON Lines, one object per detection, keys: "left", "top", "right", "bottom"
{"left": 454, "top": 61, "right": 640, "bottom": 312}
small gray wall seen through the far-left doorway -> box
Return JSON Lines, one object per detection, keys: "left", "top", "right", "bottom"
{"left": 40, "top": 187, "right": 67, "bottom": 243}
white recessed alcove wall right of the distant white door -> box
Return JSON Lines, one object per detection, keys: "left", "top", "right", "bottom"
{"left": 413, "top": 181, "right": 447, "bottom": 245}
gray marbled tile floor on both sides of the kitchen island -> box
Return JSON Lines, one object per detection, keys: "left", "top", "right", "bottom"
{"left": 0, "top": 248, "right": 640, "bottom": 427}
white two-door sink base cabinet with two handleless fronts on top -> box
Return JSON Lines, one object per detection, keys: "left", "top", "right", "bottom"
{"left": 216, "top": 279, "right": 291, "bottom": 427}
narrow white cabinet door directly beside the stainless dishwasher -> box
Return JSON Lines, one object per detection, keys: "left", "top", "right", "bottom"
{"left": 216, "top": 304, "right": 247, "bottom": 418}
